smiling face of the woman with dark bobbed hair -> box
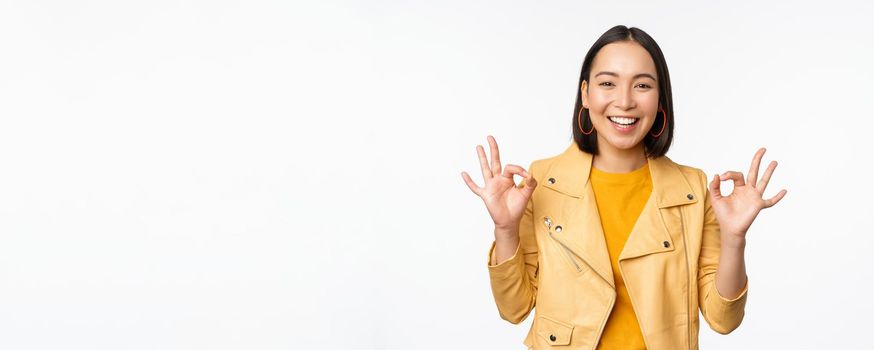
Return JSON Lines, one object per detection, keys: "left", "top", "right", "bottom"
{"left": 580, "top": 41, "right": 661, "bottom": 151}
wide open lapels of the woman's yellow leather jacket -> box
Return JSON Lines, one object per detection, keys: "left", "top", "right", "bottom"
{"left": 541, "top": 142, "right": 698, "bottom": 288}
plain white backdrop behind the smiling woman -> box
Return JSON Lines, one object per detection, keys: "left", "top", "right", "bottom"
{"left": 0, "top": 1, "right": 874, "bottom": 349}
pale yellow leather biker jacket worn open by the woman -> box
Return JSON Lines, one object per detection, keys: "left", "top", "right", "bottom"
{"left": 488, "top": 142, "right": 747, "bottom": 350}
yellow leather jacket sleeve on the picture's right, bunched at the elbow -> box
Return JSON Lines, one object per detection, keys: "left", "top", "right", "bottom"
{"left": 698, "top": 171, "right": 749, "bottom": 334}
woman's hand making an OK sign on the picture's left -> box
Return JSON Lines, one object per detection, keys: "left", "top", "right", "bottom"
{"left": 461, "top": 135, "right": 537, "bottom": 231}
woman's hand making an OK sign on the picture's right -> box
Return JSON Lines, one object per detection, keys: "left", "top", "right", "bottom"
{"left": 710, "top": 148, "right": 786, "bottom": 242}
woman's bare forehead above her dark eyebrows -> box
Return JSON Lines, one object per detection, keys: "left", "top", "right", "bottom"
{"left": 591, "top": 41, "right": 656, "bottom": 76}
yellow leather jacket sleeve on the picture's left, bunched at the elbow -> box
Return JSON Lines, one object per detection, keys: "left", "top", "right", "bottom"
{"left": 488, "top": 160, "right": 538, "bottom": 324}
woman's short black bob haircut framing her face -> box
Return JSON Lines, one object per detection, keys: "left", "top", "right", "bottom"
{"left": 572, "top": 25, "right": 674, "bottom": 158}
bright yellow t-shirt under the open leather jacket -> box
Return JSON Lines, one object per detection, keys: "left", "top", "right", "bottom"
{"left": 590, "top": 164, "right": 652, "bottom": 350}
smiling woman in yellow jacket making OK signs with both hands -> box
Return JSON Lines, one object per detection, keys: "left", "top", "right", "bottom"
{"left": 462, "top": 26, "right": 786, "bottom": 349}
